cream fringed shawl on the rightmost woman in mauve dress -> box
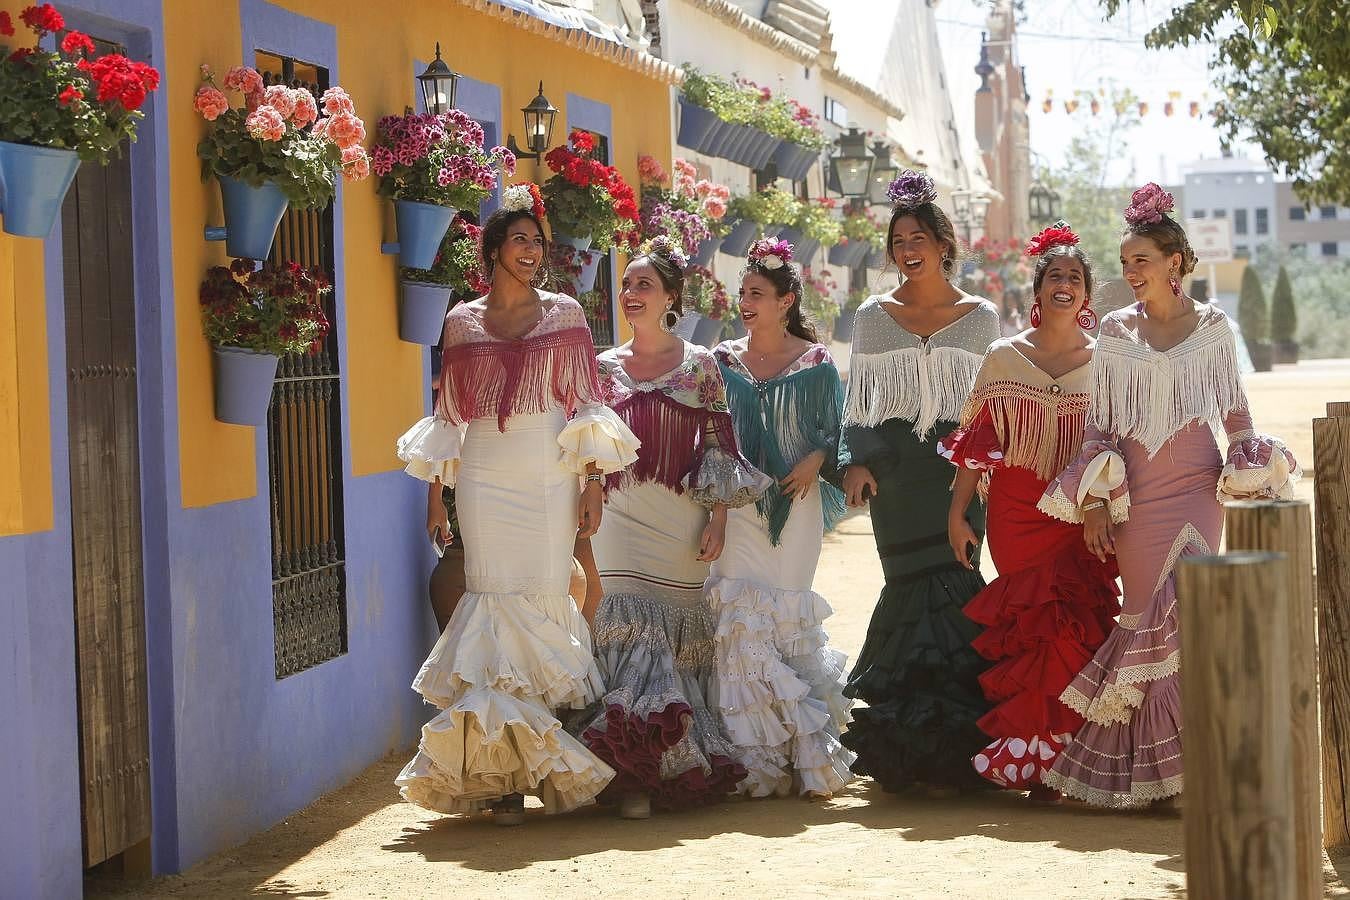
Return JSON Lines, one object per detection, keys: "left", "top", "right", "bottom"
{"left": 1089, "top": 306, "right": 1247, "bottom": 456}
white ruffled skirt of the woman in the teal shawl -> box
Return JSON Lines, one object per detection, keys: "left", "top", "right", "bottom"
{"left": 706, "top": 486, "right": 853, "bottom": 797}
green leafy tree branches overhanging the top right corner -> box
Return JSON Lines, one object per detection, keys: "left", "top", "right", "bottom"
{"left": 1100, "top": 0, "right": 1350, "bottom": 204}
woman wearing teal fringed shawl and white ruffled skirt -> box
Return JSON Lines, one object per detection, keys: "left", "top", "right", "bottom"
{"left": 707, "top": 240, "right": 853, "bottom": 797}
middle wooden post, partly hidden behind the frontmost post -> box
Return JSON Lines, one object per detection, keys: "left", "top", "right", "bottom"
{"left": 1224, "top": 501, "right": 1323, "bottom": 900}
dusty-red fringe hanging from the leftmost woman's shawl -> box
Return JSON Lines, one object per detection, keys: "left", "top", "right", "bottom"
{"left": 436, "top": 328, "right": 599, "bottom": 430}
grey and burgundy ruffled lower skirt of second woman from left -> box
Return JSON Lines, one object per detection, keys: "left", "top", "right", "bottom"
{"left": 582, "top": 594, "right": 745, "bottom": 808}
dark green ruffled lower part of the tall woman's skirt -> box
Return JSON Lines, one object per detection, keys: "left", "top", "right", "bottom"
{"left": 844, "top": 564, "right": 988, "bottom": 791}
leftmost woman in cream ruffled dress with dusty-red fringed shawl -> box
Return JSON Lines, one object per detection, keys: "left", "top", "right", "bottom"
{"left": 397, "top": 186, "right": 637, "bottom": 824}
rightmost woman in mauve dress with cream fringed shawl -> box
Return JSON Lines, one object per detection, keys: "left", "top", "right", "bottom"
{"left": 1040, "top": 184, "right": 1299, "bottom": 807}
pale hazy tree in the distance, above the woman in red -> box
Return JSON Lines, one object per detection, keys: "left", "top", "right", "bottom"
{"left": 1041, "top": 85, "right": 1139, "bottom": 281}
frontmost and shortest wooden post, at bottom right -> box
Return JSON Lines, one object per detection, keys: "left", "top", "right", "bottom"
{"left": 1177, "top": 553, "right": 1296, "bottom": 900}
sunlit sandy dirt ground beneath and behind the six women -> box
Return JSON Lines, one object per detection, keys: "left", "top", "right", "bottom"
{"left": 86, "top": 360, "right": 1350, "bottom": 900}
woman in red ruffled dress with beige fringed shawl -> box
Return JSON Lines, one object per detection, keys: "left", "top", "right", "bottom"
{"left": 938, "top": 223, "right": 1119, "bottom": 804}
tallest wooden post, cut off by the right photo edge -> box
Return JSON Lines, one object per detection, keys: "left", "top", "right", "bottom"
{"left": 1312, "top": 402, "right": 1350, "bottom": 849}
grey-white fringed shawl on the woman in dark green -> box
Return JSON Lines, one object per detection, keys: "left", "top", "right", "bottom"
{"left": 844, "top": 297, "right": 999, "bottom": 439}
